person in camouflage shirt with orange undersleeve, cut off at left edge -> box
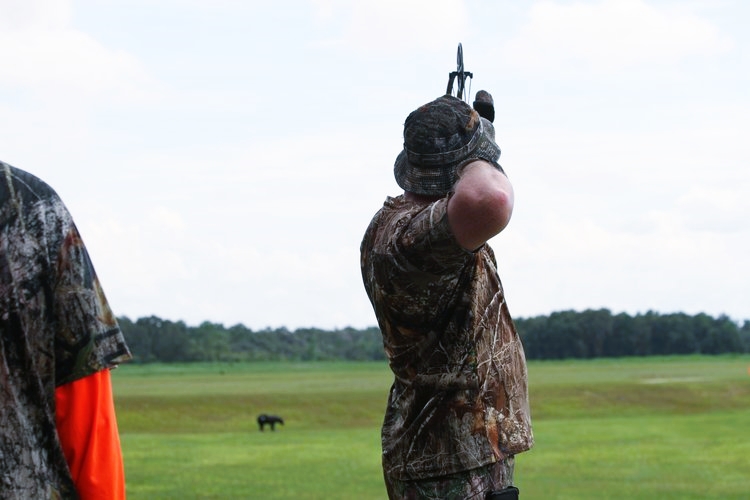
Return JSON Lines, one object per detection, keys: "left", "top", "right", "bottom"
{"left": 0, "top": 162, "right": 131, "bottom": 500}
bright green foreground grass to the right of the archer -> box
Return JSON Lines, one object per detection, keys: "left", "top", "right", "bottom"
{"left": 516, "top": 411, "right": 750, "bottom": 500}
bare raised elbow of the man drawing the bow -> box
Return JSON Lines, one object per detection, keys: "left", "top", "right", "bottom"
{"left": 448, "top": 160, "right": 513, "bottom": 250}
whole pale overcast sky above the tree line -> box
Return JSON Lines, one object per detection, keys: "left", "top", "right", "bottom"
{"left": 0, "top": 0, "right": 750, "bottom": 329}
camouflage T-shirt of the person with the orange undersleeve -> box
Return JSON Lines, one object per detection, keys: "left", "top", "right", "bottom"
{"left": 0, "top": 162, "right": 131, "bottom": 500}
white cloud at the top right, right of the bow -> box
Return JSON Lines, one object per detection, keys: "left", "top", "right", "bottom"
{"left": 505, "top": 0, "right": 731, "bottom": 71}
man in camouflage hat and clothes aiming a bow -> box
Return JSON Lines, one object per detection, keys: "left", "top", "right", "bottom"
{"left": 360, "top": 91, "right": 534, "bottom": 499}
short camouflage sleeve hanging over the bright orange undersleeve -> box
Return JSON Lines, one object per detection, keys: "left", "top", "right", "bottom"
{"left": 53, "top": 202, "right": 131, "bottom": 386}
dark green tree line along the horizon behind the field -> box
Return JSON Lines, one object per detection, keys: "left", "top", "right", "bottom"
{"left": 118, "top": 309, "right": 750, "bottom": 363}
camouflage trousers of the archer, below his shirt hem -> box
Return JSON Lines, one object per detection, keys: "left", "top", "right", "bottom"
{"left": 385, "top": 457, "right": 515, "bottom": 500}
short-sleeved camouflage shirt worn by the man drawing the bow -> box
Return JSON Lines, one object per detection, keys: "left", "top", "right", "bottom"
{"left": 361, "top": 196, "right": 533, "bottom": 480}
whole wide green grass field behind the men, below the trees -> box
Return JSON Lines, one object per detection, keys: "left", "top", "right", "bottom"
{"left": 114, "top": 356, "right": 750, "bottom": 500}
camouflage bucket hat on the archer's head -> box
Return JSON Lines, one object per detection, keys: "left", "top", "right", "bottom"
{"left": 393, "top": 95, "right": 502, "bottom": 196}
